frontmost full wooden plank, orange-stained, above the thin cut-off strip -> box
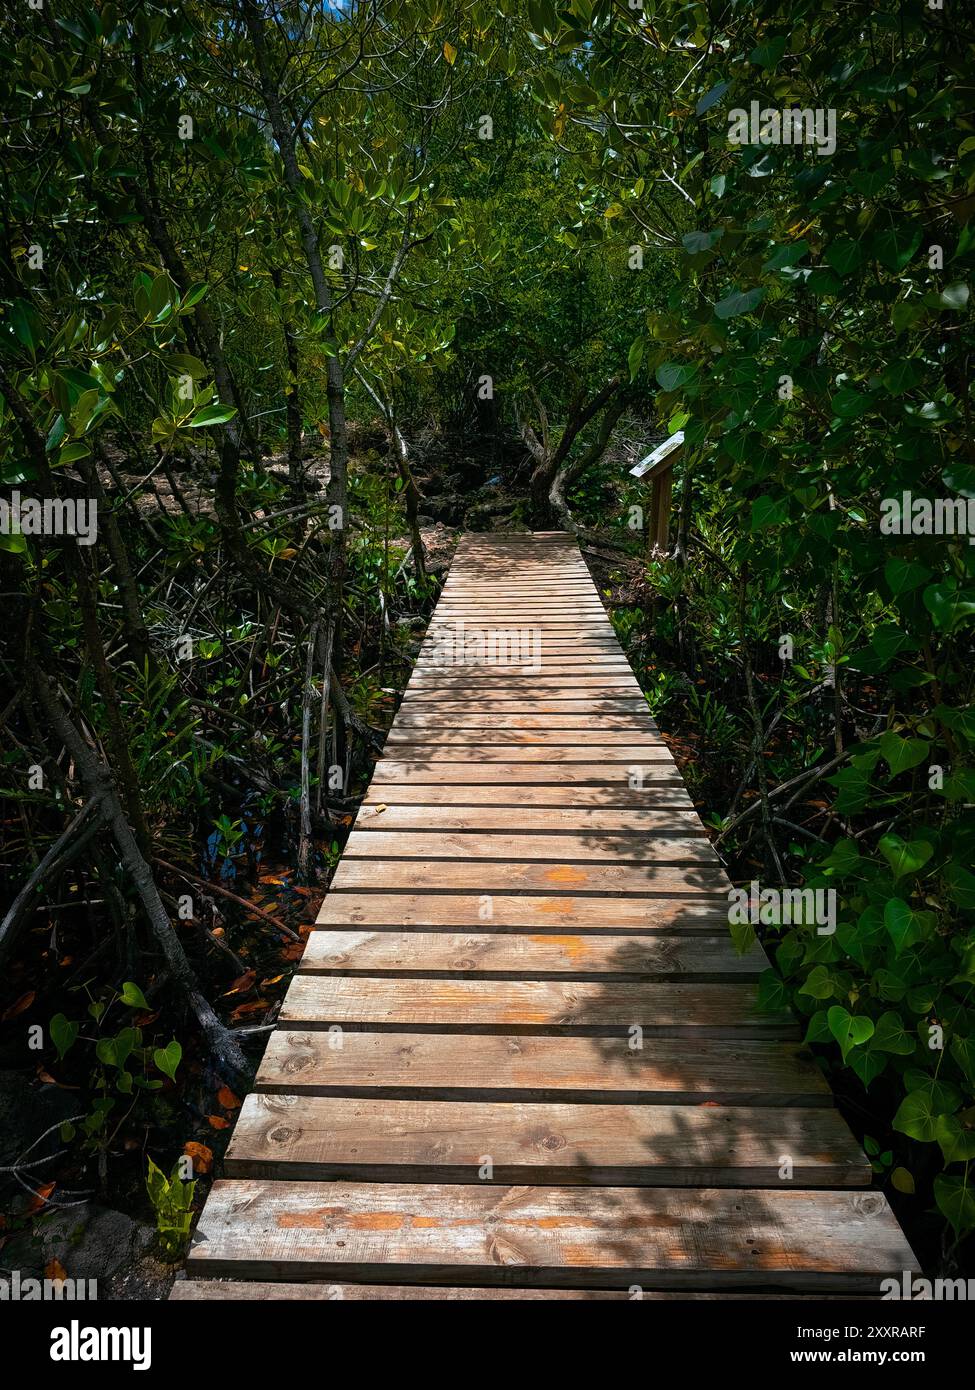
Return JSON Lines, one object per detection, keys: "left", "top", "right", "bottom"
{"left": 188, "top": 1179, "right": 919, "bottom": 1294}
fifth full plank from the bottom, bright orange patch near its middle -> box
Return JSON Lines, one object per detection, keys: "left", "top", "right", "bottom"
{"left": 300, "top": 929, "right": 768, "bottom": 984}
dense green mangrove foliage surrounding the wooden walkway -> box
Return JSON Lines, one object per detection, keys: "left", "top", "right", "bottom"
{"left": 0, "top": 0, "right": 975, "bottom": 1267}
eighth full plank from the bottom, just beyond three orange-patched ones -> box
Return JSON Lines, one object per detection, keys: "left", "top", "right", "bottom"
{"left": 345, "top": 828, "right": 719, "bottom": 865}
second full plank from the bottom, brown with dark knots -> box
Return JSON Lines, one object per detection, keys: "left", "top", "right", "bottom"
{"left": 224, "top": 1093, "right": 872, "bottom": 1188}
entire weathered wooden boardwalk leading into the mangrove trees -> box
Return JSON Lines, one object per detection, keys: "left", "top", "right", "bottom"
{"left": 174, "top": 534, "right": 918, "bottom": 1300}
